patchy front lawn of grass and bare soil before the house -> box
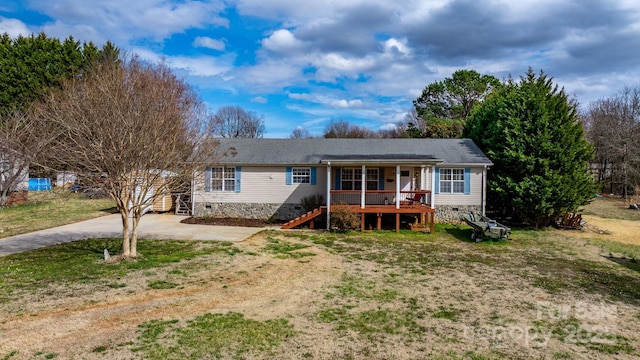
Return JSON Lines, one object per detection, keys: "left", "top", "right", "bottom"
{"left": 0, "top": 221, "right": 640, "bottom": 359}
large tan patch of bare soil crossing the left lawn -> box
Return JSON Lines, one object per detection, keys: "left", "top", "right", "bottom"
{"left": 0, "top": 234, "right": 343, "bottom": 359}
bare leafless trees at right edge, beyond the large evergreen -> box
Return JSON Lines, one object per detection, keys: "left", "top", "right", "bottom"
{"left": 583, "top": 87, "right": 640, "bottom": 198}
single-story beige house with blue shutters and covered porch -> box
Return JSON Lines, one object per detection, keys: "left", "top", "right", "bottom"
{"left": 191, "top": 139, "right": 492, "bottom": 231}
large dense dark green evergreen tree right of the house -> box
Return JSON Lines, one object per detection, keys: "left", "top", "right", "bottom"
{"left": 465, "top": 69, "right": 595, "bottom": 227}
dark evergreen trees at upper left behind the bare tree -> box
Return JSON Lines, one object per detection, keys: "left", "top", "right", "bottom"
{"left": 0, "top": 33, "right": 119, "bottom": 113}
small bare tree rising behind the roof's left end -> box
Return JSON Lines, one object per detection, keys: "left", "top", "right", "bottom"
{"left": 209, "top": 106, "right": 264, "bottom": 139}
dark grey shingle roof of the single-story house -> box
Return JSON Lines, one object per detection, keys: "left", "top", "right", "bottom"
{"left": 211, "top": 139, "right": 492, "bottom": 165}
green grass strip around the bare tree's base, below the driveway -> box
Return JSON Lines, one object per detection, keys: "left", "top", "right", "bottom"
{"left": 0, "top": 239, "right": 239, "bottom": 302}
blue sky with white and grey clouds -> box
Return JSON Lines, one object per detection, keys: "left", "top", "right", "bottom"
{"left": 0, "top": 0, "right": 640, "bottom": 138}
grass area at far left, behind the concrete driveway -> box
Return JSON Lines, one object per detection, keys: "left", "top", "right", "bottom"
{"left": 0, "top": 190, "right": 115, "bottom": 238}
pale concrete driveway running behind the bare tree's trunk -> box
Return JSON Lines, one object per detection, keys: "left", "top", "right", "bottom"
{"left": 0, "top": 214, "right": 264, "bottom": 256}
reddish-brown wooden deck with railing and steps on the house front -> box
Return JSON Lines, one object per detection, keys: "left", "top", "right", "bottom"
{"left": 282, "top": 202, "right": 435, "bottom": 233}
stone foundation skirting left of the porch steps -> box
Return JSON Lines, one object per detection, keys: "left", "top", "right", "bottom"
{"left": 193, "top": 203, "right": 304, "bottom": 221}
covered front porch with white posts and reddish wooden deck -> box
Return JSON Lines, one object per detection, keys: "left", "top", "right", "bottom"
{"left": 283, "top": 159, "right": 441, "bottom": 232}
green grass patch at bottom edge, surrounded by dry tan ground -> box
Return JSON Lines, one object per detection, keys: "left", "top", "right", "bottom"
{"left": 133, "top": 312, "right": 296, "bottom": 359}
